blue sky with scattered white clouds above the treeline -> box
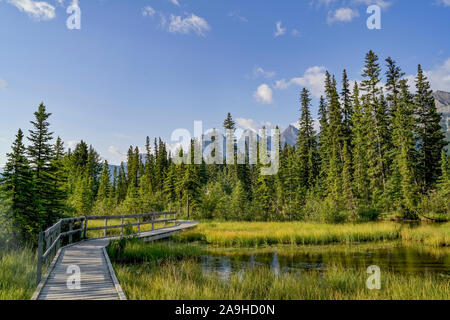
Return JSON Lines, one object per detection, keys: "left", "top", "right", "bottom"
{"left": 0, "top": 0, "right": 450, "bottom": 166}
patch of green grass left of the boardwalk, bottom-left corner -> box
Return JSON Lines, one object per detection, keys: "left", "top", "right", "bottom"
{"left": 0, "top": 248, "right": 37, "bottom": 300}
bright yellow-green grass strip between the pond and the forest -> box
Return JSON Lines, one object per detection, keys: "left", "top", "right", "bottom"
{"left": 175, "top": 222, "right": 450, "bottom": 247}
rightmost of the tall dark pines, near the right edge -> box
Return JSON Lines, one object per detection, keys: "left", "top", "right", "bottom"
{"left": 414, "top": 65, "right": 447, "bottom": 191}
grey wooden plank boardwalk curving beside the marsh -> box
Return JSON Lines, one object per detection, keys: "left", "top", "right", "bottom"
{"left": 32, "top": 222, "right": 197, "bottom": 300}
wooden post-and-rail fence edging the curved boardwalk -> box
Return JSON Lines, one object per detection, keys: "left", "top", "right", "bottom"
{"left": 36, "top": 212, "right": 177, "bottom": 284}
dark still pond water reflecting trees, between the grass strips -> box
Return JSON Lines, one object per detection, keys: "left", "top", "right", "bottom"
{"left": 200, "top": 244, "right": 450, "bottom": 279}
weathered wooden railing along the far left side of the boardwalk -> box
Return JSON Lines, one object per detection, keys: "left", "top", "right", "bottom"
{"left": 36, "top": 211, "right": 177, "bottom": 285}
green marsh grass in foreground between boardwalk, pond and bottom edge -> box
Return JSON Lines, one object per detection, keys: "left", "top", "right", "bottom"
{"left": 115, "top": 259, "right": 450, "bottom": 300}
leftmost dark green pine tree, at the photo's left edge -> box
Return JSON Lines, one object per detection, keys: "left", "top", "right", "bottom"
{"left": 0, "top": 129, "right": 37, "bottom": 241}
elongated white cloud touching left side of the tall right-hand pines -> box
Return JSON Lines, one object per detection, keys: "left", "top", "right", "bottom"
{"left": 275, "top": 66, "right": 326, "bottom": 98}
